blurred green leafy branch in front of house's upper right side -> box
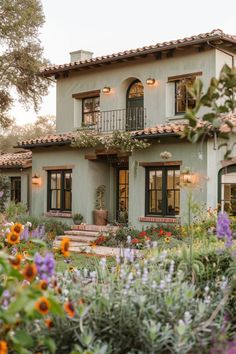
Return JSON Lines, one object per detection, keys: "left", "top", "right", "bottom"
{"left": 181, "top": 65, "right": 236, "bottom": 157}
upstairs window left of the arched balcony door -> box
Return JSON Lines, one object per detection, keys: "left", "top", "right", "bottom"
{"left": 82, "top": 96, "right": 100, "bottom": 126}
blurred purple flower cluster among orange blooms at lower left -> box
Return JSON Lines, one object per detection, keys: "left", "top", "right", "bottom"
{"left": 34, "top": 252, "right": 55, "bottom": 281}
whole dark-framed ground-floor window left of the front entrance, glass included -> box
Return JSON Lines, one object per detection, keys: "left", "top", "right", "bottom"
{"left": 48, "top": 170, "right": 72, "bottom": 212}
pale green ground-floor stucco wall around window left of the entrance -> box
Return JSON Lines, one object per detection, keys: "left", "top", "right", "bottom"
{"left": 32, "top": 147, "right": 114, "bottom": 223}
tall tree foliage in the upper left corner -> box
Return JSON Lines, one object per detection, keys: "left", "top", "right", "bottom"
{"left": 0, "top": 0, "right": 49, "bottom": 127}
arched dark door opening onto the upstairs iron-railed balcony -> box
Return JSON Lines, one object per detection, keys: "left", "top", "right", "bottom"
{"left": 126, "top": 80, "right": 144, "bottom": 131}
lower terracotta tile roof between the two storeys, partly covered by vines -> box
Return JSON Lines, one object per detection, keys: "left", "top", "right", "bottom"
{"left": 18, "top": 113, "right": 236, "bottom": 148}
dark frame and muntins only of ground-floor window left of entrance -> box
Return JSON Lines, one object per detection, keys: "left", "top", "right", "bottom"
{"left": 47, "top": 169, "right": 72, "bottom": 212}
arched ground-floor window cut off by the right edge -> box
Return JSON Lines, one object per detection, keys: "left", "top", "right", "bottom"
{"left": 218, "top": 165, "right": 236, "bottom": 215}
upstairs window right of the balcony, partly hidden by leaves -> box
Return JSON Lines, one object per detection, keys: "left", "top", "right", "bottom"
{"left": 175, "top": 77, "right": 196, "bottom": 114}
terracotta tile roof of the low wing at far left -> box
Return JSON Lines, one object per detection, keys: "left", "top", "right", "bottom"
{"left": 0, "top": 151, "right": 32, "bottom": 169}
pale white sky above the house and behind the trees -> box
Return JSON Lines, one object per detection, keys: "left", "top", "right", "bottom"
{"left": 11, "top": 0, "right": 236, "bottom": 124}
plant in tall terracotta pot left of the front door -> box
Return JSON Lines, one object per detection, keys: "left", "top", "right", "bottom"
{"left": 93, "top": 185, "right": 108, "bottom": 225}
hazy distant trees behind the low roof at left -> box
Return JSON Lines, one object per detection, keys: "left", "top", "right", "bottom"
{"left": 0, "top": 116, "right": 56, "bottom": 153}
